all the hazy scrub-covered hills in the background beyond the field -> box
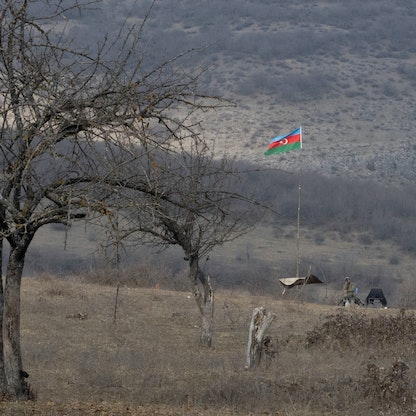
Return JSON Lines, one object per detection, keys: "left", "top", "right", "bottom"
{"left": 21, "top": 0, "right": 416, "bottom": 305}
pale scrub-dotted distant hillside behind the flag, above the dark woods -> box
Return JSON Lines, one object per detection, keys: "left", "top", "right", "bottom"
{"left": 67, "top": 0, "right": 416, "bottom": 184}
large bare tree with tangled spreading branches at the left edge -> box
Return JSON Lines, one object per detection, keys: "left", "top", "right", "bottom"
{"left": 0, "top": 0, "right": 223, "bottom": 397}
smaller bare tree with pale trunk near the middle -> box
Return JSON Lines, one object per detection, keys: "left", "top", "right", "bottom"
{"left": 109, "top": 135, "right": 257, "bottom": 346}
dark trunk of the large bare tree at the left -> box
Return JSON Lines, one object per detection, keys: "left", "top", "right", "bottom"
{"left": 3, "top": 247, "right": 29, "bottom": 398}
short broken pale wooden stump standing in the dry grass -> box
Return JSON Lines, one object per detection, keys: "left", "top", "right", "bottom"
{"left": 246, "top": 307, "right": 274, "bottom": 369}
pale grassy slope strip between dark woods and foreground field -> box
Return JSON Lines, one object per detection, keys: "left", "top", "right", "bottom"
{"left": 25, "top": 210, "right": 416, "bottom": 308}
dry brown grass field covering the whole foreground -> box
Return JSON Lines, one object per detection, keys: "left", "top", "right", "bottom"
{"left": 0, "top": 277, "right": 416, "bottom": 416}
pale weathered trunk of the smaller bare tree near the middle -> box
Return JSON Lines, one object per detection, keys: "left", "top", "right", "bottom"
{"left": 189, "top": 257, "right": 214, "bottom": 347}
